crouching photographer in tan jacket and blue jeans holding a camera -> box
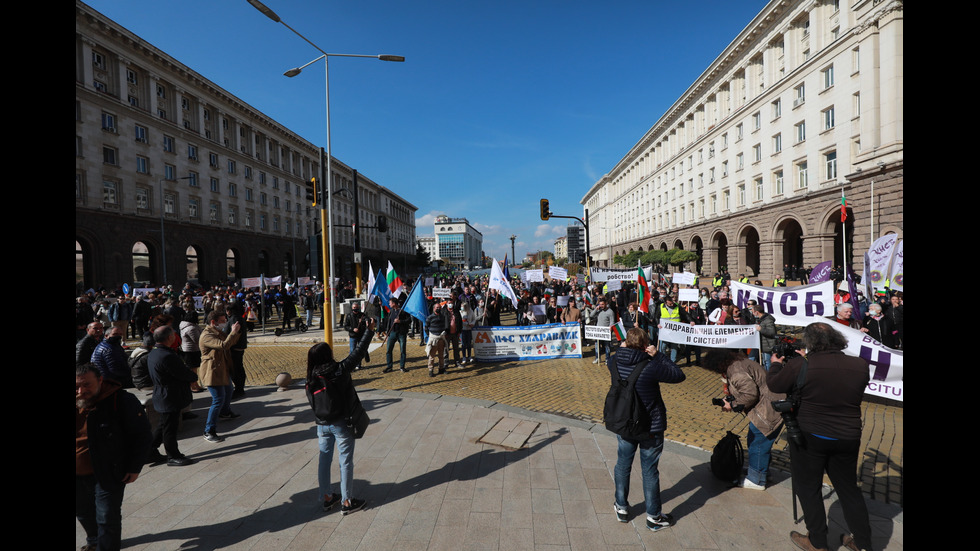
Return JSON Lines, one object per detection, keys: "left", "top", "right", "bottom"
{"left": 701, "top": 348, "right": 785, "bottom": 490}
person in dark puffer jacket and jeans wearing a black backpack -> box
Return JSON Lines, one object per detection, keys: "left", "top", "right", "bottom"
{"left": 606, "top": 327, "right": 687, "bottom": 532}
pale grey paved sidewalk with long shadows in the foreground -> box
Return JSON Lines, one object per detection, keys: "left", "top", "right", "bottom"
{"left": 75, "top": 383, "right": 904, "bottom": 551}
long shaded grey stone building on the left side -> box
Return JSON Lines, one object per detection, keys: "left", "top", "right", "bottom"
{"left": 75, "top": 1, "right": 415, "bottom": 294}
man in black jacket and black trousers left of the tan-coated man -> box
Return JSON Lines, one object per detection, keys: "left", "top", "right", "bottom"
{"left": 147, "top": 325, "right": 197, "bottom": 467}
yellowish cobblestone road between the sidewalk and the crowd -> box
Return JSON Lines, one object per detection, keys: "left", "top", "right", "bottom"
{"left": 237, "top": 312, "right": 904, "bottom": 505}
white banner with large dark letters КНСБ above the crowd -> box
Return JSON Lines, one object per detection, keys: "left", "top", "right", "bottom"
{"left": 731, "top": 281, "right": 834, "bottom": 326}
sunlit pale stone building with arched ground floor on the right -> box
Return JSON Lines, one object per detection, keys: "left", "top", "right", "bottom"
{"left": 581, "top": 0, "right": 904, "bottom": 279}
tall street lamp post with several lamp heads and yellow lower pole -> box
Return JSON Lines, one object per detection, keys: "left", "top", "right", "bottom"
{"left": 248, "top": 0, "right": 405, "bottom": 346}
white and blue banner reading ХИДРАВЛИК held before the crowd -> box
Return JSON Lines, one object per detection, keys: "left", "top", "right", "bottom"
{"left": 473, "top": 322, "right": 582, "bottom": 362}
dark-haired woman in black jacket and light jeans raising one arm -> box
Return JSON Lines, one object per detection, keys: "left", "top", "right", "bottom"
{"left": 306, "top": 318, "right": 375, "bottom": 515}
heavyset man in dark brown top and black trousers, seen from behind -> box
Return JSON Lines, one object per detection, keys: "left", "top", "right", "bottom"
{"left": 766, "top": 322, "right": 871, "bottom": 551}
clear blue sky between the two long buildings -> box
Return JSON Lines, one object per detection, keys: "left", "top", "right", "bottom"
{"left": 88, "top": 0, "right": 766, "bottom": 260}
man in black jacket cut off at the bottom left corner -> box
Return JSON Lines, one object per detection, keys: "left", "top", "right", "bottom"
{"left": 75, "top": 363, "right": 153, "bottom": 549}
